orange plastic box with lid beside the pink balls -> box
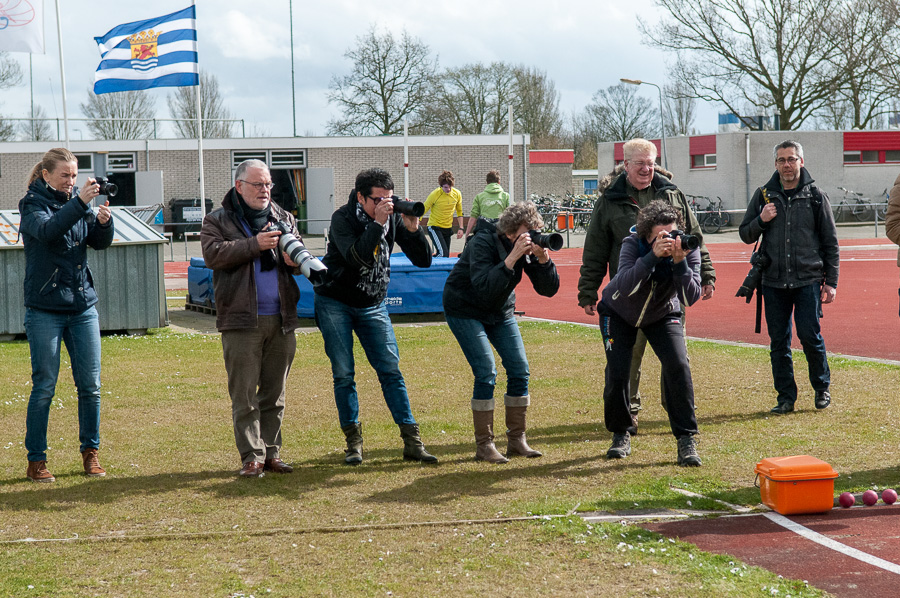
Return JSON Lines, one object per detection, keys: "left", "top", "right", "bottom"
{"left": 756, "top": 455, "right": 838, "bottom": 515}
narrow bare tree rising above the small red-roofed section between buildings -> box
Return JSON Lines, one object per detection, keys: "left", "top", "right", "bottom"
{"left": 513, "top": 66, "right": 565, "bottom": 148}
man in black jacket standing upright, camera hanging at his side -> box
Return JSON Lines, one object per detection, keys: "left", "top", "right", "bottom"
{"left": 740, "top": 140, "right": 840, "bottom": 415}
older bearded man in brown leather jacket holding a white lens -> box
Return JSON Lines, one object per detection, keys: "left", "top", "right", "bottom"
{"left": 200, "top": 160, "right": 300, "bottom": 477}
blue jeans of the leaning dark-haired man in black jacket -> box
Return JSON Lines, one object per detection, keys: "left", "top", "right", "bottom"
{"left": 315, "top": 294, "right": 416, "bottom": 427}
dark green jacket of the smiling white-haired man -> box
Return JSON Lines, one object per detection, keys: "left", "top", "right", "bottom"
{"left": 578, "top": 169, "right": 716, "bottom": 307}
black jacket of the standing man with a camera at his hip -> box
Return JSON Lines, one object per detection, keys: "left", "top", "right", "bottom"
{"left": 740, "top": 168, "right": 840, "bottom": 289}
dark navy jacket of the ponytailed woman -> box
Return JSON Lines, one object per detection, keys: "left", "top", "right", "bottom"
{"left": 19, "top": 177, "right": 114, "bottom": 313}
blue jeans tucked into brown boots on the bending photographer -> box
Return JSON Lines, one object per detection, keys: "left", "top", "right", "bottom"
{"left": 446, "top": 315, "right": 529, "bottom": 401}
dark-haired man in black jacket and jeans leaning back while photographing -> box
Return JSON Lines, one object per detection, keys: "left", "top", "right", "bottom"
{"left": 315, "top": 168, "right": 437, "bottom": 465}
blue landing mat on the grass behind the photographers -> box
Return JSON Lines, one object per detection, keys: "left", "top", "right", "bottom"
{"left": 188, "top": 253, "right": 459, "bottom": 318}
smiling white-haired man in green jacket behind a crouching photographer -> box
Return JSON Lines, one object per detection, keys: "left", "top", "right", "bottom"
{"left": 578, "top": 138, "right": 716, "bottom": 433}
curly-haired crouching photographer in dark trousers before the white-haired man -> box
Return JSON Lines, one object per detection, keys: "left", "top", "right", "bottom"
{"left": 599, "top": 200, "right": 701, "bottom": 467}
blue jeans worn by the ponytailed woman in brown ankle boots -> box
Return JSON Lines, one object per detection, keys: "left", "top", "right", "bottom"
{"left": 25, "top": 307, "right": 100, "bottom": 461}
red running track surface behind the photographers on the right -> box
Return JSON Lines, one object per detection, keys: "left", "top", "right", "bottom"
{"left": 516, "top": 239, "right": 900, "bottom": 361}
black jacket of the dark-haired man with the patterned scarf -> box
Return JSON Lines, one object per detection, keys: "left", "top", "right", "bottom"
{"left": 315, "top": 191, "right": 431, "bottom": 307}
